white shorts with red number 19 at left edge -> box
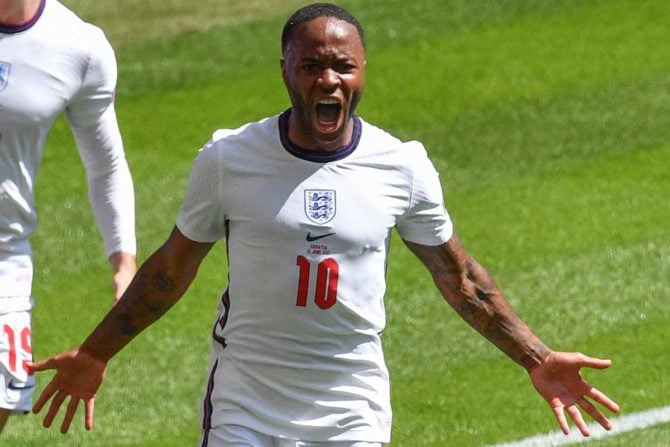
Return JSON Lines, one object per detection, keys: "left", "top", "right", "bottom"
{"left": 0, "top": 310, "right": 35, "bottom": 414}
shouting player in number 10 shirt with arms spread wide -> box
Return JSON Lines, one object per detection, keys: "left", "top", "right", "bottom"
{"left": 31, "top": 3, "right": 618, "bottom": 447}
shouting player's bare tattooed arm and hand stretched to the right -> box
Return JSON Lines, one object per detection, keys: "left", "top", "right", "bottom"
{"left": 405, "top": 235, "right": 619, "bottom": 436}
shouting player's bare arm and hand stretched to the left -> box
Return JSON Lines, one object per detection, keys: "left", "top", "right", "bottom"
{"left": 28, "top": 228, "right": 213, "bottom": 433}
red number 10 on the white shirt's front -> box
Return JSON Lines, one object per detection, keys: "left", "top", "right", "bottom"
{"left": 295, "top": 256, "right": 340, "bottom": 309}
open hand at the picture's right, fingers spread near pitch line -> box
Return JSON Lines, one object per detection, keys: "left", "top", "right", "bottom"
{"left": 529, "top": 352, "right": 619, "bottom": 436}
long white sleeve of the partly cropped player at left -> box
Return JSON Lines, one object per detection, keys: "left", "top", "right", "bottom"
{"left": 66, "top": 27, "right": 136, "bottom": 256}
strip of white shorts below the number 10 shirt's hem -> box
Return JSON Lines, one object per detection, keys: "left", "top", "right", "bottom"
{"left": 198, "top": 425, "right": 383, "bottom": 447}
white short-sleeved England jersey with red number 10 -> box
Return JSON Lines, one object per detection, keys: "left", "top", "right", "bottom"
{"left": 177, "top": 112, "right": 452, "bottom": 442}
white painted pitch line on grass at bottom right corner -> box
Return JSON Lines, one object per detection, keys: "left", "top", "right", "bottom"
{"left": 491, "top": 406, "right": 670, "bottom": 447}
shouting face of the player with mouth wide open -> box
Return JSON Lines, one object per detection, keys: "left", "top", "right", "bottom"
{"left": 281, "top": 17, "right": 365, "bottom": 150}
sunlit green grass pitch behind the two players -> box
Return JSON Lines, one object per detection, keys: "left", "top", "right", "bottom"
{"left": 6, "top": 0, "right": 670, "bottom": 447}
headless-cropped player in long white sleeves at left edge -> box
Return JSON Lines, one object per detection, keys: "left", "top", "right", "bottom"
{"left": 0, "top": 0, "right": 136, "bottom": 431}
